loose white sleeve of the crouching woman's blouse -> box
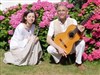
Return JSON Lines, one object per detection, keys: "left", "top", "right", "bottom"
{"left": 10, "top": 26, "right": 28, "bottom": 50}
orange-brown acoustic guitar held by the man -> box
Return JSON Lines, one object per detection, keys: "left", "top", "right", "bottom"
{"left": 54, "top": 6, "right": 99, "bottom": 55}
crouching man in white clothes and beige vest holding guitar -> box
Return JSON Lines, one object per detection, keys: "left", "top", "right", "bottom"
{"left": 47, "top": 5, "right": 85, "bottom": 69}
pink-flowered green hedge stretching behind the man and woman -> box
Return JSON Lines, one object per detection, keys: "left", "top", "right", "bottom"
{"left": 0, "top": 0, "right": 100, "bottom": 61}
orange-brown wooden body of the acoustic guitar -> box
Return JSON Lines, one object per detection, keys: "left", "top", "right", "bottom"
{"left": 54, "top": 24, "right": 80, "bottom": 54}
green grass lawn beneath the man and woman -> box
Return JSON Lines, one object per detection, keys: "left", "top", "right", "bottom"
{"left": 0, "top": 50, "right": 100, "bottom": 75}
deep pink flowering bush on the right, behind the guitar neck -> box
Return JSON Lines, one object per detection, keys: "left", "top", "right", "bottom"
{"left": 78, "top": 0, "right": 100, "bottom": 61}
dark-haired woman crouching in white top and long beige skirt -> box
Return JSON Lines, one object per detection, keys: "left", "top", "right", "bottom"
{"left": 3, "top": 10, "right": 42, "bottom": 66}
